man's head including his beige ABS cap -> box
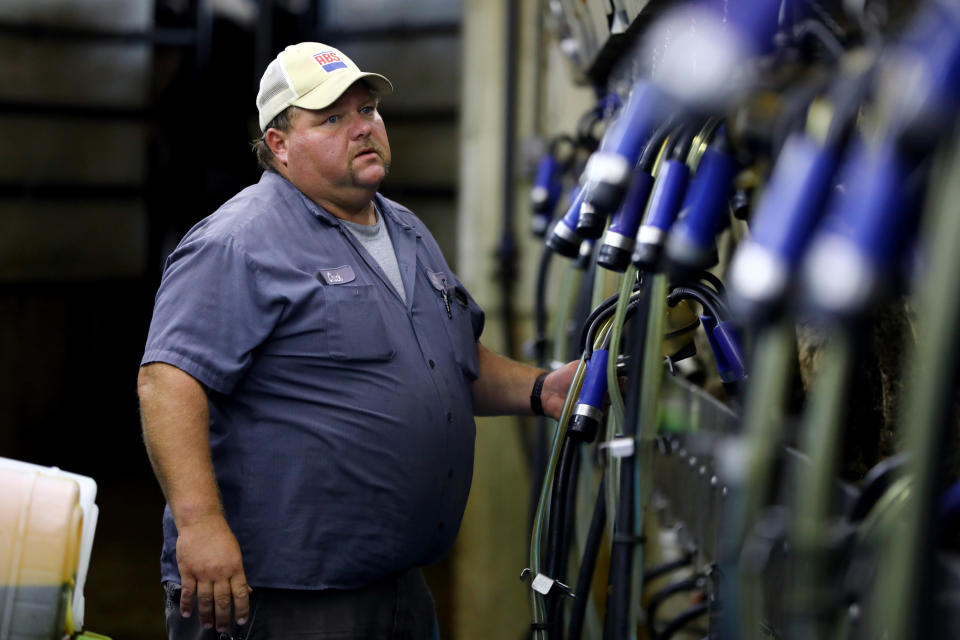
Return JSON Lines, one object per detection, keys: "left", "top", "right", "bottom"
{"left": 254, "top": 43, "right": 392, "bottom": 218}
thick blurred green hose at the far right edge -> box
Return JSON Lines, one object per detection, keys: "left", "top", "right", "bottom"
{"left": 875, "top": 135, "right": 960, "bottom": 640}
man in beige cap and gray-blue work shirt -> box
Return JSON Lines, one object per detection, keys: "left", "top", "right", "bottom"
{"left": 138, "top": 42, "right": 573, "bottom": 639}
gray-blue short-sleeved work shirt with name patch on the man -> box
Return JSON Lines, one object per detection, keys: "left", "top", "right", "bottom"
{"left": 142, "top": 173, "right": 484, "bottom": 589}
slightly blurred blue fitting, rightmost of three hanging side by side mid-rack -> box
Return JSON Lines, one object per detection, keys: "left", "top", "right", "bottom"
{"left": 666, "top": 147, "right": 737, "bottom": 269}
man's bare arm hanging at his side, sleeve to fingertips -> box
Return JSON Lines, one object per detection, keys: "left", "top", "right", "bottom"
{"left": 137, "top": 362, "right": 250, "bottom": 632}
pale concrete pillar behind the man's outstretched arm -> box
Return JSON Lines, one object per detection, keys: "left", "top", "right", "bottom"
{"left": 453, "top": 0, "right": 592, "bottom": 639}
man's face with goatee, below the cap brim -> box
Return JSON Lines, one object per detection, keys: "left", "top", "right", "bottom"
{"left": 274, "top": 82, "right": 390, "bottom": 211}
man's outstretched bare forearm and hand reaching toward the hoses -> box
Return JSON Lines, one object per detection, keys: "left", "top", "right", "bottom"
{"left": 473, "top": 342, "right": 577, "bottom": 419}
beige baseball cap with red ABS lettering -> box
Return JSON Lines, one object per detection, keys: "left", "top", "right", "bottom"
{"left": 257, "top": 42, "right": 393, "bottom": 131}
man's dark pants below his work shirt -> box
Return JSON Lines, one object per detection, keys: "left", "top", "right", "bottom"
{"left": 164, "top": 569, "right": 440, "bottom": 640}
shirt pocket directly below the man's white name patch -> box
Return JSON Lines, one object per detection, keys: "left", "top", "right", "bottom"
{"left": 323, "top": 284, "right": 397, "bottom": 362}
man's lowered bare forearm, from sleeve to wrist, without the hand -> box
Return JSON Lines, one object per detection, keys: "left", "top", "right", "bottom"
{"left": 137, "top": 363, "right": 221, "bottom": 526}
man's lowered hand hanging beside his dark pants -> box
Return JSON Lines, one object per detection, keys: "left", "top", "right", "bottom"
{"left": 177, "top": 514, "right": 251, "bottom": 633}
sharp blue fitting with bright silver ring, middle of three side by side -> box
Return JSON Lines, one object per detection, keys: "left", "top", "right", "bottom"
{"left": 632, "top": 160, "right": 690, "bottom": 270}
